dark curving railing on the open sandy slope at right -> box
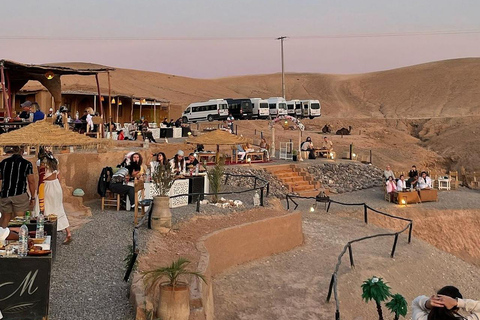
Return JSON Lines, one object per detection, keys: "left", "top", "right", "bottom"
{"left": 286, "top": 194, "right": 413, "bottom": 320}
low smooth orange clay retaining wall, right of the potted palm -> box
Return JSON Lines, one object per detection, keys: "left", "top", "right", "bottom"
{"left": 190, "top": 212, "right": 303, "bottom": 320}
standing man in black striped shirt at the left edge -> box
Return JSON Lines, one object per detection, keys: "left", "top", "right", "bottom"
{"left": 0, "top": 146, "right": 36, "bottom": 228}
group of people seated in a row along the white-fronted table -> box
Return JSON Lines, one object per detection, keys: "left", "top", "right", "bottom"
{"left": 108, "top": 150, "right": 201, "bottom": 209}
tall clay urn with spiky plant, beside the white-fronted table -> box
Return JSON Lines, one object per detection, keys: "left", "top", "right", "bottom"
{"left": 152, "top": 164, "right": 175, "bottom": 230}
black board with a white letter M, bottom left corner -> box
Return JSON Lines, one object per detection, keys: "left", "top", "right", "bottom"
{"left": 0, "top": 256, "right": 52, "bottom": 320}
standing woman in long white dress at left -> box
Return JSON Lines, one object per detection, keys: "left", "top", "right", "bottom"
{"left": 37, "top": 152, "right": 72, "bottom": 244}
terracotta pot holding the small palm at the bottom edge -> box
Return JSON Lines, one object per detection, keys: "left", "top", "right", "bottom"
{"left": 157, "top": 284, "right": 190, "bottom": 320}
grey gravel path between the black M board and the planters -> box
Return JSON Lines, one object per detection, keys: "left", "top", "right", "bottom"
{"left": 49, "top": 201, "right": 138, "bottom": 320}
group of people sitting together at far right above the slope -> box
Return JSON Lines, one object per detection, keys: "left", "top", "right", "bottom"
{"left": 383, "top": 165, "right": 432, "bottom": 200}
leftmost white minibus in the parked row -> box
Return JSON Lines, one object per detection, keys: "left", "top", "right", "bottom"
{"left": 182, "top": 99, "right": 228, "bottom": 123}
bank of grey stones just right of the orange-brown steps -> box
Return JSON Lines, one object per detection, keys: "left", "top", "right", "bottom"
{"left": 307, "top": 163, "right": 385, "bottom": 193}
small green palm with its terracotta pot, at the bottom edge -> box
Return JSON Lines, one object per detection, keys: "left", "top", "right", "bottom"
{"left": 144, "top": 258, "right": 207, "bottom": 320}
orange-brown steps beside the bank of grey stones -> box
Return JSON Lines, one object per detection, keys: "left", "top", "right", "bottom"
{"left": 265, "top": 164, "right": 328, "bottom": 197}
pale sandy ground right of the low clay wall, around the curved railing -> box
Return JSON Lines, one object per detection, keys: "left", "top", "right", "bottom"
{"left": 214, "top": 191, "right": 480, "bottom": 320}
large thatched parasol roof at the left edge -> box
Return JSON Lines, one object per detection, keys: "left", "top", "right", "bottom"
{"left": 0, "top": 121, "right": 110, "bottom": 147}
